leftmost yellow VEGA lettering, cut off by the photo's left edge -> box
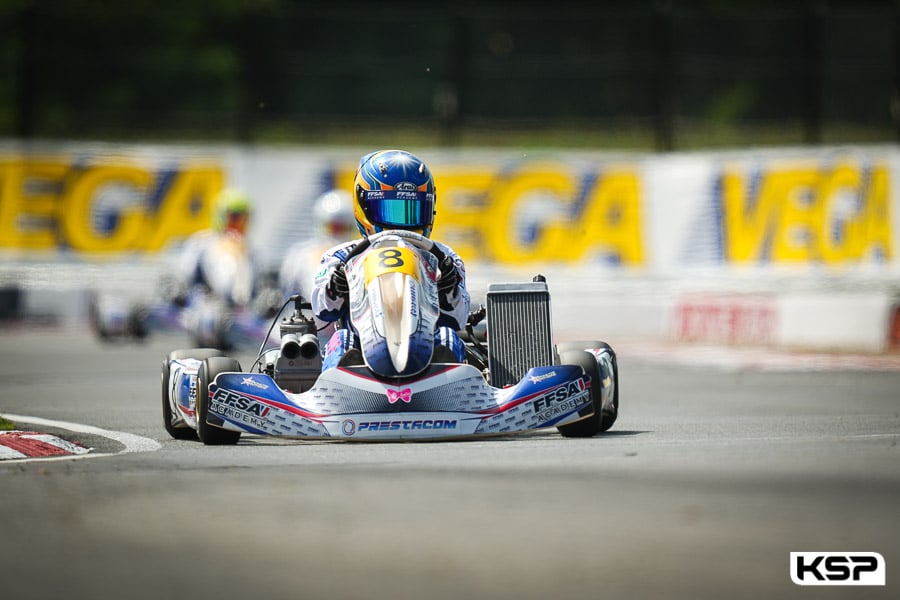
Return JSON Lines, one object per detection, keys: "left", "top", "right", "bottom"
{"left": 0, "top": 159, "right": 224, "bottom": 253}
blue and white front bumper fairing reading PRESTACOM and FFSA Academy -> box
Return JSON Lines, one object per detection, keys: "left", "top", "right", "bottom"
{"left": 212, "top": 364, "right": 593, "bottom": 440}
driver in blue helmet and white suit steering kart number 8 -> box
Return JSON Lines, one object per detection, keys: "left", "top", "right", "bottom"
{"left": 310, "top": 150, "right": 470, "bottom": 370}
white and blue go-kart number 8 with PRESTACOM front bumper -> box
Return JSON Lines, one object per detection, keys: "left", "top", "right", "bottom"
{"left": 162, "top": 231, "right": 619, "bottom": 444}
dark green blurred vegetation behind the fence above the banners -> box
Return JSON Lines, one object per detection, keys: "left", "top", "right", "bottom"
{"left": 0, "top": 0, "right": 900, "bottom": 150}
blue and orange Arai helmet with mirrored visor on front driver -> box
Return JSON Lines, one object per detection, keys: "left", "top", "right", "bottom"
{"left": 353, "top": 150, "right": 436, "bottom": 237}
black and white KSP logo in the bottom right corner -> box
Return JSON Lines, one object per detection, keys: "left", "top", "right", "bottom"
{"left": 791, "top": 552, "right": 885, "bottom": 585}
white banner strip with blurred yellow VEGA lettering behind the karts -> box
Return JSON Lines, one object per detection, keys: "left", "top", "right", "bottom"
{"left": 0, "top": 143, "right": 900, "bottom": 274}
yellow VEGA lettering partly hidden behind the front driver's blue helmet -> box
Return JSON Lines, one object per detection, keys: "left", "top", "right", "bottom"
{"left": 335, "top": 164, "right": 644, "bottom": 265}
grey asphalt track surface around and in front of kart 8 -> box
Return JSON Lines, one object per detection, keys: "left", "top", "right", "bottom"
{"left": 0, "top": 326, "right": 900, "bottom": 600}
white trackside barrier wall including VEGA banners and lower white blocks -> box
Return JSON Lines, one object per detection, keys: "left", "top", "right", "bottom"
{"left": 0, "top": 141, "right": 900, "bottom": 352}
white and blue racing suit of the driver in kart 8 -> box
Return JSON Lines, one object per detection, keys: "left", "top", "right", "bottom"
{"left": 310, "top": 240, "right": 470, "bottom": 371}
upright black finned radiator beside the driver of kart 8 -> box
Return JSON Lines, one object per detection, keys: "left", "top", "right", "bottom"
{"left": 487, "top": 281, "right": 553, "bottom": 387}
